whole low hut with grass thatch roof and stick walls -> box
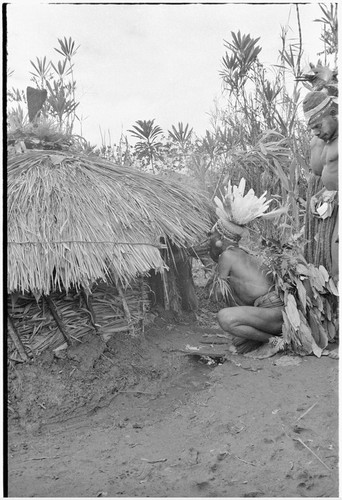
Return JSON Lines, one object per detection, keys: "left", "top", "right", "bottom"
{"left": 7, "top": 146, "right": 211, "bottom": 361}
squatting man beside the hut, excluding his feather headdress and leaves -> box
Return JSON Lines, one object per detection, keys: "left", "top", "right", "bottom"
{"left": 210, "top": 222, "right": 283, "bottom": 359}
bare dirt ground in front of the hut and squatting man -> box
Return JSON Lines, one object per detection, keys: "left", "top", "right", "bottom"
{"left": 8, "top": 298, "right": 339, "bottom": 498}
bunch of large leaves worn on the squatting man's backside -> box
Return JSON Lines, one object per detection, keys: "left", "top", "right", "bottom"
{"left": 262, "top": 236, "right": 338, "bottom": 357}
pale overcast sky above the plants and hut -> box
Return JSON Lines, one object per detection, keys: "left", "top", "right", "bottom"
{"left": 7, "top": 0, "right": 332, "bottom": 145}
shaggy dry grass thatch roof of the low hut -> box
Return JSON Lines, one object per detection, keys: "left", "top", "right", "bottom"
{"left": 8, "top": 150, "right": 211, "bottom": 294}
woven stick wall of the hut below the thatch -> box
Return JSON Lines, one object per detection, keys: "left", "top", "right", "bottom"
{"left": 8, "top": 278, "right": 150, "bottom": 362}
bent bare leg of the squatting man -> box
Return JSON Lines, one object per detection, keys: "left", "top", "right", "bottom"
{"left": 217, "top": 306, "right": 283, "bottom": 342}
